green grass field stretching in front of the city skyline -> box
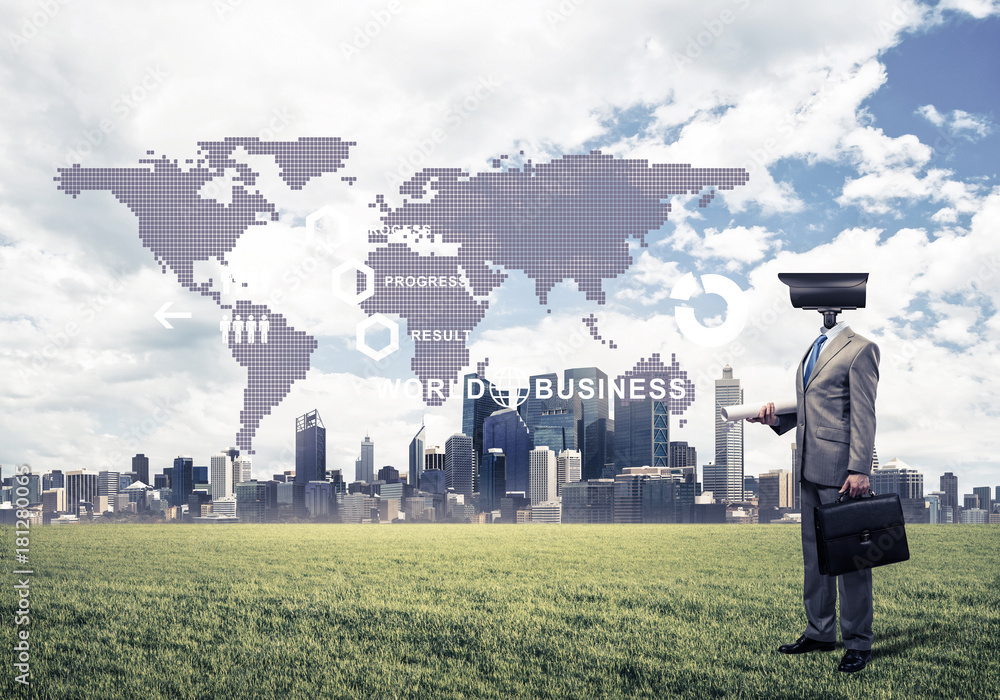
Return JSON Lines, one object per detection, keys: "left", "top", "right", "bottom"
{"left": 0, "top": 525, "right": 1000, "bottom": 699}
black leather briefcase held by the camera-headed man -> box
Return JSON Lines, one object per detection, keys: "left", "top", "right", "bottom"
{"left": 815, "top": 491, "right": 910, "bottom": 576}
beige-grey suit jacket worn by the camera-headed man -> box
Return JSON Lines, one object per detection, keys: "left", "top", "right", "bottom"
{"left": 774, "top": 326, "right": 880, "bottom": 486}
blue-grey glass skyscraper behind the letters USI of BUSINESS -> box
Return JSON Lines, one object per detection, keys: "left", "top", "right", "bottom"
{"left": 563, "top": 367, "right": 615, "bottom": 479}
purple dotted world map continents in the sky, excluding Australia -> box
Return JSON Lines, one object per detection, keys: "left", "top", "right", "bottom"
{"left": 54, "top": 137, "right": 749, "bottom": 454}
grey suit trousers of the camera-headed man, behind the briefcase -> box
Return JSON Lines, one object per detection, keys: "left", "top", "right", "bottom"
{"left": 802, "top": 480, "right": 874, "bottom": 651}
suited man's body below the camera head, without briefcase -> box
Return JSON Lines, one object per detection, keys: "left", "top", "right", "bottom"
{"left": 747, "top": 322, "right": 879, "bottom": 673}
